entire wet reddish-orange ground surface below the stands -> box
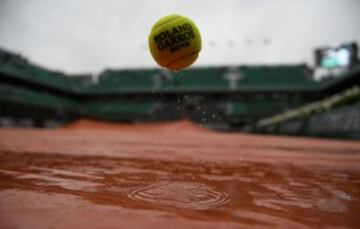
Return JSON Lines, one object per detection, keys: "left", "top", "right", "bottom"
{"left": 0, "top": 120, "right": 360, "bottom": 228}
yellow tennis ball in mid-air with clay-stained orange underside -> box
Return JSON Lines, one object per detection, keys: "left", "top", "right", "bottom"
{"left": 149, "top": 14, "right": 201, "bottom": 70}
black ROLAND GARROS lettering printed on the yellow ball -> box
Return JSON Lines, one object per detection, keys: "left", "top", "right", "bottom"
{"left": 154, "top": 23, "right": 195, "bottom": 52}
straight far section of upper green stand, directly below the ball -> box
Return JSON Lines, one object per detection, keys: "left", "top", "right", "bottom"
{"left": 87, "top": 65, "right": 319, "bottom": 93}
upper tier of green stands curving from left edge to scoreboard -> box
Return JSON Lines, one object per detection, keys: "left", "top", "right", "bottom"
{"left": 0, "top": 50, "right": 320, "bottom": 94}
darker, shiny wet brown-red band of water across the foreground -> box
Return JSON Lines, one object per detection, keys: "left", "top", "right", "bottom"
{"left": 0, "top": 152, "right": 360, "bottom": 228}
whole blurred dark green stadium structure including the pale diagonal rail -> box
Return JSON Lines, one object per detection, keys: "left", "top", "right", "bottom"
{"left": 0, "top": 43, "right": 360, "bottom": 138}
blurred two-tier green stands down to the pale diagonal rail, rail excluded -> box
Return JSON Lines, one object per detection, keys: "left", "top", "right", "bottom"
{"left": 0, "top": 49, "right": 360, "bottom": 138}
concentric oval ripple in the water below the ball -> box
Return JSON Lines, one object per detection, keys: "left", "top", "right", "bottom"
{"left": 128, "top": 181, "right": 230, "bottom": 210}
